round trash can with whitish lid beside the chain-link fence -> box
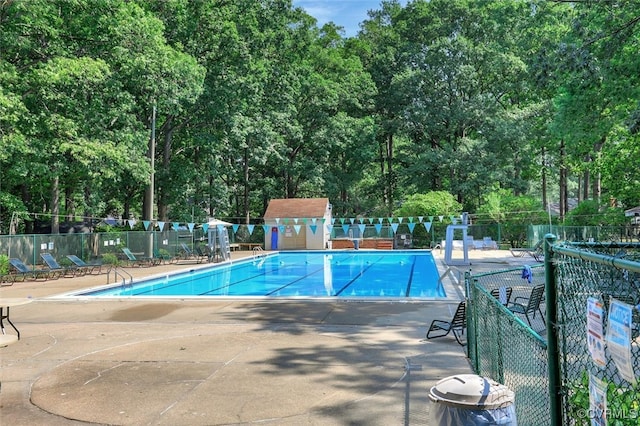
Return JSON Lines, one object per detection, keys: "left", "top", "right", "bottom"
{"left": 429, "top": 374, "right": 518, "bottom": 426}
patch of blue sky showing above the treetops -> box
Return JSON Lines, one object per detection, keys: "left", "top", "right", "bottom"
{"left": 293, "top": 0, "right": 407, "bottom": 37}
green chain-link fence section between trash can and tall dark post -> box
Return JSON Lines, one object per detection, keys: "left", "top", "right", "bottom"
{"left": 466, "top": 265, "right": 550, "bottom": 425}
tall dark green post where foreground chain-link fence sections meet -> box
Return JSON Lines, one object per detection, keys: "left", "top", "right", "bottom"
{"left": 544, "top": 234, "right": 562, "bottom": 426}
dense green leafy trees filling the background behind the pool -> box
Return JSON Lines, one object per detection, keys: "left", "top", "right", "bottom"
{"left": 0, "top": 0, "right": 640, "bottom": 233}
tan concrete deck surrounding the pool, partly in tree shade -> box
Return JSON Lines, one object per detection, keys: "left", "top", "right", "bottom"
{"left": 0, "top": 250, "right": 535, "bottom": 425}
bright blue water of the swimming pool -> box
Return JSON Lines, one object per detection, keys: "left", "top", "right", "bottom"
{"left": 81, "top": 250, "right": 446, "bottom": 298}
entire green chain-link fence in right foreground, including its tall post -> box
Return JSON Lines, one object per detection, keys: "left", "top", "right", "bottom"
{"left": 465, "top": 238, "right": 640, "bottom": 425}
